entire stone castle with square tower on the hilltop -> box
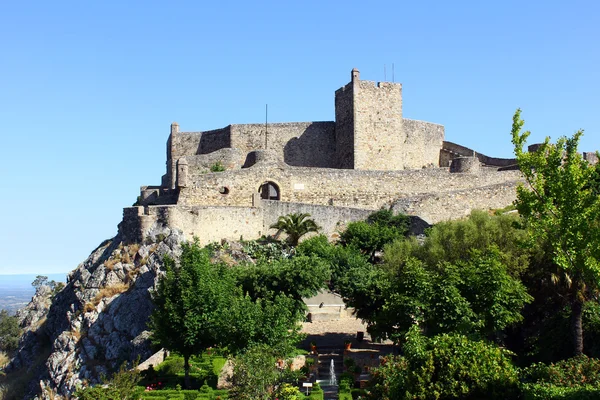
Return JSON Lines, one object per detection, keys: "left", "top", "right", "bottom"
{"left": 119, "top": 69, "right": 520, "bottom": 244}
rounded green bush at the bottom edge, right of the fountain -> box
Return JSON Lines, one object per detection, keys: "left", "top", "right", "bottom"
{"left": 371, "top": 327, "right": 519, "bottom": 400}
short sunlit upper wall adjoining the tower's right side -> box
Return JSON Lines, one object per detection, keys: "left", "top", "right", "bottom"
{"left": 402, "top": 118, "right": 448, "bottom": 168}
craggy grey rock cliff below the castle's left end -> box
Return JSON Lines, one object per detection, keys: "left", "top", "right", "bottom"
{"left": 8, "top": 227, "right": 183, "bottom": 398}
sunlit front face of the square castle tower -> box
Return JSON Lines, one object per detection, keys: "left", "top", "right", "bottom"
{"left": 354, "top": 81, "right": 404, "bottom": 170}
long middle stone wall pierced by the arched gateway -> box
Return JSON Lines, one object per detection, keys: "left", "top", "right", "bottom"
{"left": 179, "top": 164, "right": 520, "bottom": 209}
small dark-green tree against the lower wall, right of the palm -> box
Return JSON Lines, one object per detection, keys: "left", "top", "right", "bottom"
{"left": 340, "top": 209, "right": 409, "bottom": 261}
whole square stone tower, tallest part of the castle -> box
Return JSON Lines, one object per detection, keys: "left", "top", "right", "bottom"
{"left": 335, "top": 68, "right": 404, "bottom": 170}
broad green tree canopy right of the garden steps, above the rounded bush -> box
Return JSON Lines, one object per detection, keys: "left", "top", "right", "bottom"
{"left": 340, "top": 251, "right": 531, "bottom": 341}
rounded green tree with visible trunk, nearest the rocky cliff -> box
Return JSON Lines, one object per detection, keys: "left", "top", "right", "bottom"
{"left": 150, "top": 243, "right": 236, "bottom": 387}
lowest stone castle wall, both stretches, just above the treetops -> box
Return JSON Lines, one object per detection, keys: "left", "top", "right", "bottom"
{"left": 119, "top": 177, "right": 517, "bottom": 245}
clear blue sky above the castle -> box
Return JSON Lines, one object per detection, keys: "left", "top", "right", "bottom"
{"left": 0, "top": 0, "right": 600, "bottom": 274}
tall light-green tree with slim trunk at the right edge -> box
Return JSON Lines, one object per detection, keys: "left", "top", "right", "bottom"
{"left": 512, "top": 110, "right": 600, "bottom": 355}
